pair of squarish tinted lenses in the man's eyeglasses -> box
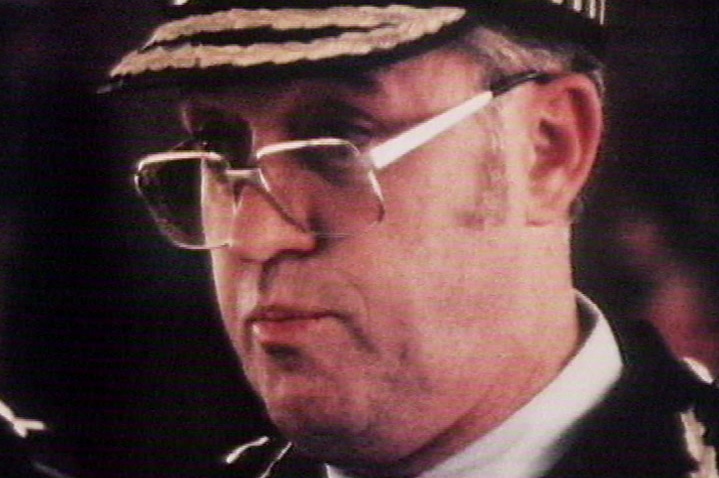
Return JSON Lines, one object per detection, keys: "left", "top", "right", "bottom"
{"left": 136, "top": 141, "right": 384, "bottom": 249}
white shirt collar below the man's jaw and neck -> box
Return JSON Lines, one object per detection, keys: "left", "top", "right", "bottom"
{"left": 328, "top": 293, "right": 622, "bottom": 478}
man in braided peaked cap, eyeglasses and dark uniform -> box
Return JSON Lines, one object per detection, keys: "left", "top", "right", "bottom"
{"left": 104, "top": 0, "right": 717, "bottom": 478}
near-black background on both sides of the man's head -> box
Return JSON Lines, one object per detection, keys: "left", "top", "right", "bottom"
{"left": 0, "top": 0, "right": 719, "bottom": 478}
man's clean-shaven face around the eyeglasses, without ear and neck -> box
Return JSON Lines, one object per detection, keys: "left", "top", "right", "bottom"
{"left": 183, "top": 47, "right": 542, "bottom": 467}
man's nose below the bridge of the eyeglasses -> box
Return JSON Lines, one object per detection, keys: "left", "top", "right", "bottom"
{"left": 229, "top": 185, "right": 317, "bottom": 262}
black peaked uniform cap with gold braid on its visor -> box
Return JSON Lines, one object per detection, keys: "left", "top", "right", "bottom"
{"left": 101, "top": 0, "right": 605, "bottom": 92}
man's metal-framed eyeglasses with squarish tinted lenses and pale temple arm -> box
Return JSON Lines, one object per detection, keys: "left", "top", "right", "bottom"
{"left": 135, "top": 71, "right": 553, "bottom": 250}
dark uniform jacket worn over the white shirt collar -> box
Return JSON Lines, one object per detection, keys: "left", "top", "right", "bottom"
{"left": 228, "top": 321, "right": 719, "bottom": 478}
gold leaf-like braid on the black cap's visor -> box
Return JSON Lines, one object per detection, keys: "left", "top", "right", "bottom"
{"left": 110, "top": 5, "right": 466, "bottom": 78}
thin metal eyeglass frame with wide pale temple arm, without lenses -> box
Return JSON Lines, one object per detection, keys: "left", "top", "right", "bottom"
{"left": 133, "top": 70, "right": 558, "bottom": 250}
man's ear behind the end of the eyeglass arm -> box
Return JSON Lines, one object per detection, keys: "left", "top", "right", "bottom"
{"left": 527, "top": 74, "right": 602, "bottom": 226}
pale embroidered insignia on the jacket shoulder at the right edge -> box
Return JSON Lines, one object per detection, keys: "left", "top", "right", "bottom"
{"left": 681, "top": 359, "right": 719, "bottom": 478}
